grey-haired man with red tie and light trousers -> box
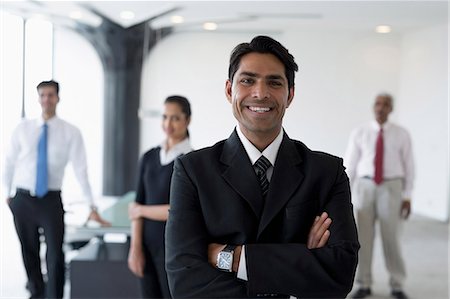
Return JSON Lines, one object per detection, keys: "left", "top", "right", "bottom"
{"left": 345, "top": 94, "right": 414, "bottom": 299}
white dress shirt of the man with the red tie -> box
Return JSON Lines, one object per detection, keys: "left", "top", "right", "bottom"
{"left": 344, "top": 121, "right": 414, "bottom": 199}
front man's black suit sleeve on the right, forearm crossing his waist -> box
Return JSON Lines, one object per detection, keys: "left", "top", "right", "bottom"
{"left": 246, "top": 159, "right": 359, "bottom": 298}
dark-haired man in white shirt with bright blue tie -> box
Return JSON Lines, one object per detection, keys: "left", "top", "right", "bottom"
{"left": 3, "top": 80, "right": 109, "bottom": 298}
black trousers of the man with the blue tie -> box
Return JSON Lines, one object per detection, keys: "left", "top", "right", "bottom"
{"left": 10, "top": 190, "right": 65, "bottom": 298}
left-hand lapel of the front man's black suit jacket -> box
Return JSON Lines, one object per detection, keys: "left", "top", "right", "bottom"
{"left": 220, "top": 130, "right": 263, "bottom": 218}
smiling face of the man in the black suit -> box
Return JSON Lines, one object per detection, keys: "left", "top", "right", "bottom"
{"left": 225, "top": 52, "right": 294, "bottom": 136}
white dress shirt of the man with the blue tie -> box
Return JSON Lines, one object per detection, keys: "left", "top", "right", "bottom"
{"left": 3, "top": 116, "right": 94, "bottom": 207}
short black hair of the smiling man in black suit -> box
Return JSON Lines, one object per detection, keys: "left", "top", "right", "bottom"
{"left": 228, "top": 35, "right": 298, "bottom": 88}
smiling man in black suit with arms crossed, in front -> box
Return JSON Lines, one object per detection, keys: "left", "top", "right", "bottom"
{"left": 166, "top": 36, "right": 359, "bottom": 298}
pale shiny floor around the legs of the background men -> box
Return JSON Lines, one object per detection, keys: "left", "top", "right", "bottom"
{"left": 0, "top": 204, "right": 449, "bottom": 299}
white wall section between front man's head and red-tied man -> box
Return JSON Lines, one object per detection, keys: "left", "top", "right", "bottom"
{"left": 282, "top": 32, "right": 400, "bottom": 156}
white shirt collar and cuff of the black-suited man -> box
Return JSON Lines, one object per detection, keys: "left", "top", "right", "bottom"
{"left": 236, "top": 125, "right": 284, "bottom": 280}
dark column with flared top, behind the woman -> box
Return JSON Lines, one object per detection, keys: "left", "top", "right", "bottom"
{"left": 76, "top": 17, "right": 171, "bottom": 195}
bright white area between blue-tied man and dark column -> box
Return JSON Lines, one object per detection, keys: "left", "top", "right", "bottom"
{"left": 54, "top": 27, "right": 104, "bottom": 203}
